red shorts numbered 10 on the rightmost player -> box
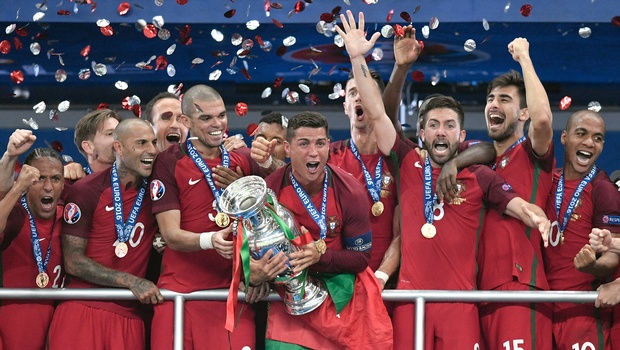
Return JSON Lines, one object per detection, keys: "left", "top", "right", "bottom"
{"left": 553, "top": 304, "right": 611, "bottom": 350}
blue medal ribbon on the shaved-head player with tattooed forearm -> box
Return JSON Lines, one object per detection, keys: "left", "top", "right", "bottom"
{"left": 111, "top": 163, "right": 148, "bottom": 242}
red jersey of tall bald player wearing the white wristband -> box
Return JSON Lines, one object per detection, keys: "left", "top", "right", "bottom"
{"left": 150, "top": 144, "right": 262, "bottom": 293}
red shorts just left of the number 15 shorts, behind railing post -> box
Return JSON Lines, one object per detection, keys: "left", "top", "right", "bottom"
{"left": 392, "top": 303, "right": 481, "bottom": 350}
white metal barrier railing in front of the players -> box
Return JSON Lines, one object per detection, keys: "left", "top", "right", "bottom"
{"left": 0, "top": 288, "right": 598, "bottom": 350}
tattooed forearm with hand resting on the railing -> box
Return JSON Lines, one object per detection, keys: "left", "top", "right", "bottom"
{"left": 62, "top": 234, "right": 164, "bottom": 304}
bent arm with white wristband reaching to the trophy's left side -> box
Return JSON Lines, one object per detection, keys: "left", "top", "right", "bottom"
{"left": 155, "top": 210, "right": 233, "bottom": 259}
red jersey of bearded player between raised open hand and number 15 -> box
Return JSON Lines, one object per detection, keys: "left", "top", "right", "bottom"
{"left": 392, "top": 140, "right": 516, "bottom": 290}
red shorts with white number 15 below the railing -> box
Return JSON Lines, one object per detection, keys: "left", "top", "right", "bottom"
{"left": 479, "top": 282, "right": 552, "bottom": 350}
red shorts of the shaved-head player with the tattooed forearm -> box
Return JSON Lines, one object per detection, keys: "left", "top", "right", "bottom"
{"left": 49, "top": 301, "right": 145, "bottom": 350}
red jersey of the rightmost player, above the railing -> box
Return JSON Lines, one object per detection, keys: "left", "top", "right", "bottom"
{"left": 544, "top": 169, "right": 620, "bottom": 291}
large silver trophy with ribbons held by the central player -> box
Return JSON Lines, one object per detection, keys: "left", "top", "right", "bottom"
{"left": 219, "top": 176, "right": 328, "bottom": 315}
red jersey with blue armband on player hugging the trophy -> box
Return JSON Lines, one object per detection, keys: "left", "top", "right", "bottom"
{"left": 265, "top": 164, "right": 372, "bottom": 273}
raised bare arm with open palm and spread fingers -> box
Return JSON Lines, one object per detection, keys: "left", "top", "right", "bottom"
{"left": 336, "top": 10, "right": 397, "bottom": 155}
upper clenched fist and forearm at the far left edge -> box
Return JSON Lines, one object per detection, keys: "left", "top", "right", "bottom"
{"left": 0, "top": 129, "right": 37, "bottom": 196}
